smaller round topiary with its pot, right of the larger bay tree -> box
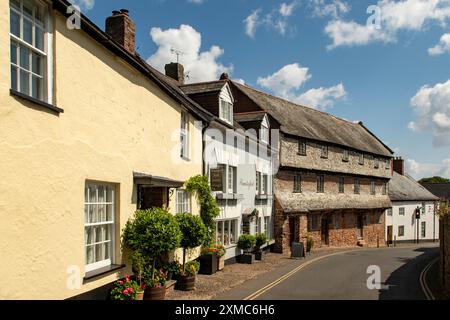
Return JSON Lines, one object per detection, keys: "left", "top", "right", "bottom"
{"left": 175, "top": 213, "right": 207, "bottom": 291}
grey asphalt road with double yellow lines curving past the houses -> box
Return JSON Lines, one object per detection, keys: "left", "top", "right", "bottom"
{"left": 214, "top": 244, "right": 439, "bottom": 300}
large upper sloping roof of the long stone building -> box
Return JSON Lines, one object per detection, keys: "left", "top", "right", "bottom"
{"left": 232, "top": 82, "right": 393, "bottom": 157}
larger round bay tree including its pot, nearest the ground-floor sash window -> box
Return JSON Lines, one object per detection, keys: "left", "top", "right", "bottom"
{"left": 123, "top": 208, "right": 181, "bottom": 300}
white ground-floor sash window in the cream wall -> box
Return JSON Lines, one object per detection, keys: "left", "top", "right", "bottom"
{"left": 84, "top": 183, "right": 116, "bottom": 272}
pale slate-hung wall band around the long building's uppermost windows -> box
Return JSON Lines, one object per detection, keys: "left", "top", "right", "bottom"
{"left": 280, "top": 136, "right": 391, "bottom": 179}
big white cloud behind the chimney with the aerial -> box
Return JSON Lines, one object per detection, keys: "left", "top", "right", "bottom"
{"left": 147, "top": 24, "right": 233, "bottom": 82}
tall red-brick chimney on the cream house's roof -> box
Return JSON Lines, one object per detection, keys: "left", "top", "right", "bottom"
{"left": 106, "top": 9, "right": 136, "bottom": 55}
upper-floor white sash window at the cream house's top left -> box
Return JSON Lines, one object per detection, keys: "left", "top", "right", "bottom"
{"left": 9, "top": 0, "right": 51, "bottom": 102}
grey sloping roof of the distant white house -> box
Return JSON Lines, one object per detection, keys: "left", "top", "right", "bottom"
{"left": 389, "top": 171, "right": 438, "bottom": 201}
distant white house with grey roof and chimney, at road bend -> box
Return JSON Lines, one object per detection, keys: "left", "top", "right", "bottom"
{"left": 386, "top": 158, "right": 439, "bottom": 243}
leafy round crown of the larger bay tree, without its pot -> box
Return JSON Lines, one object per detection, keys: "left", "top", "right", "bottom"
{"left": 123, "top": 208, "right": 182, "bottom": 279}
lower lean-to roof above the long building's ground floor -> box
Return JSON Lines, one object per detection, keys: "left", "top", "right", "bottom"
{"left": 275, "top": 190, "right": 392, "bottom": 213}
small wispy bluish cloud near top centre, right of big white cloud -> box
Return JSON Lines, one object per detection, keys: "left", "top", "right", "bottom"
{"left": 244, "top": 0, "right": 298, "bottom": 38}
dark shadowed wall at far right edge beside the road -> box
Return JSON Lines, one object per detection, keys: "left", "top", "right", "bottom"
{"left": 439, "top": 215, "right": 450, "bottom": 295}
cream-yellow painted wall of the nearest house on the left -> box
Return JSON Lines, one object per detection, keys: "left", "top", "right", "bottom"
{"left": 0, "top": 6, "right": 202, "bottom": 299}
